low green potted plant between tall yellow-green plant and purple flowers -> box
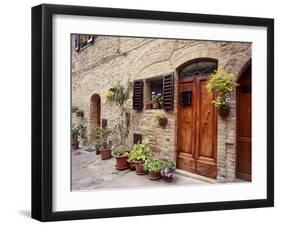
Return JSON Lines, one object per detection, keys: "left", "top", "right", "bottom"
{"left": 144, "top": 158, "right": 162, "bottom": 180}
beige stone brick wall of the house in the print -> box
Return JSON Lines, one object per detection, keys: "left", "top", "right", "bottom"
{"left": 72, "top": 36, "right": 251, "bottom": 182}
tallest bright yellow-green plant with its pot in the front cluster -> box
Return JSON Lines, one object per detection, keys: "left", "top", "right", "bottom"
{"left": 128, "top": 138, "right": 150, "bottom": 175}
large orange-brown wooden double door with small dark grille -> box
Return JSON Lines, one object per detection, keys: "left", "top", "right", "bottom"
{"left": 177, "top": 76, "right": 217, "bottom": 178}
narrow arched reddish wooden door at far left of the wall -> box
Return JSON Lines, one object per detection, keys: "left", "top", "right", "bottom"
{"left": 90, "top": 94, "right": 101, "bottom": 140}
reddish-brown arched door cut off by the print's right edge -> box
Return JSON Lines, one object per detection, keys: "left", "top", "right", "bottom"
{"left": 236, "top": 67, "right": 252, "bottom": 181}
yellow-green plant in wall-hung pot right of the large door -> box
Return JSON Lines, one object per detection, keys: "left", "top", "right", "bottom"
{"left": 206, "top": 69, "right": 238, "bottom": 118}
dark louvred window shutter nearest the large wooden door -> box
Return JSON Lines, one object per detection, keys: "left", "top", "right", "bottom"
{"left": 163, "top": 73, "right": 174, "bottom": 111}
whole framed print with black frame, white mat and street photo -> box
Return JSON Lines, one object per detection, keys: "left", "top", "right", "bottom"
{"left": 32, "top": 4, "right": 274, "bottom": 221}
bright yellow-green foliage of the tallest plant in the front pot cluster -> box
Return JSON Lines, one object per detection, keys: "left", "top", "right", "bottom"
{"left": 128, "top": 138, "right": 151, "bottom": 161}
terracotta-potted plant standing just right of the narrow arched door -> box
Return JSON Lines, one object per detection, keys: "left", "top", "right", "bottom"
{"left": 96, "top": 126, "right": 111, "bottom": 160}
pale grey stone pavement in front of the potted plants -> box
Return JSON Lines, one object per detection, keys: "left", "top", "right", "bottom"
{"left": 72, "top": 149, "right": 208, "bottom": 191}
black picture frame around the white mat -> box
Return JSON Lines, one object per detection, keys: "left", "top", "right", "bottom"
{"left": 32, "top": 4, "right": 274, "bottom": 221}
